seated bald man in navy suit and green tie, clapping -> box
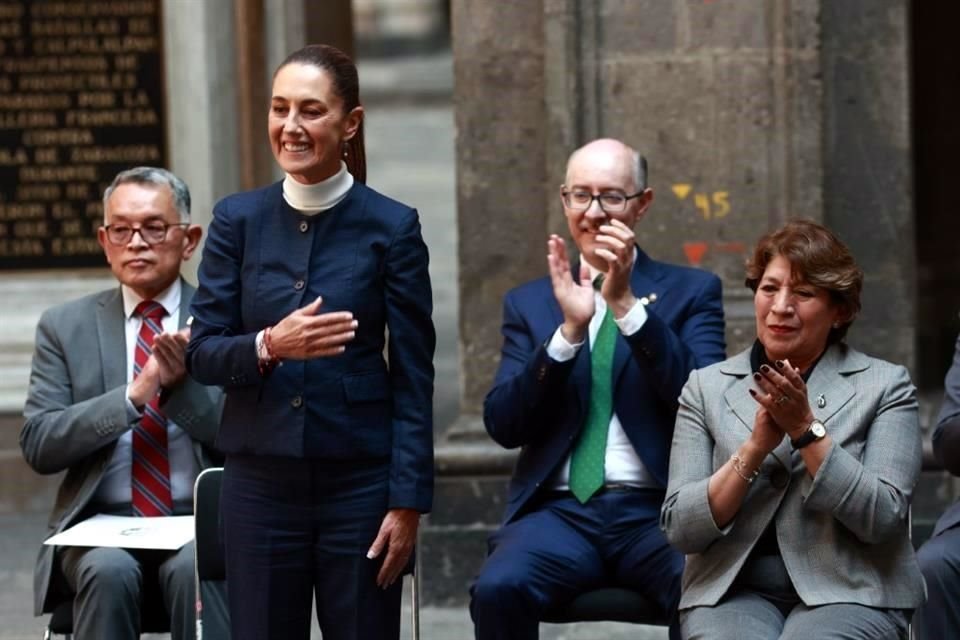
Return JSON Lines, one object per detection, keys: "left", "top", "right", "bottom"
{"left": 470, "top": 139, "right": 724, "bottom": 640}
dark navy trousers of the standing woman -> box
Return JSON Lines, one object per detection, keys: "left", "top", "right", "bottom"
{"left": 221, "top": 456, "right": 402, "bottom": 640}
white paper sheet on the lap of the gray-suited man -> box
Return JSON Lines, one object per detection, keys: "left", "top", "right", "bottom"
{"left": 43, "top": 515, "right": 193, "bottom": 549}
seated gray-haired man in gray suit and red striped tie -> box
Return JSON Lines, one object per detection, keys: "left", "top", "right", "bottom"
{"left": 20, "top": 167, "right": 226, "bottom": 640}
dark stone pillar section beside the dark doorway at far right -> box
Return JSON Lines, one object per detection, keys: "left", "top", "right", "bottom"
{"left": 821, "top": 0, "right": 912, "bottom": 370}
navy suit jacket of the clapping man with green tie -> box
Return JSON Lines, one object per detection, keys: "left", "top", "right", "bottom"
{"left": 483, "top": 247, "right": 725, "bottom": 523}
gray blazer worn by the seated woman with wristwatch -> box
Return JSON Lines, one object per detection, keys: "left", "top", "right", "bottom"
{"left": 661, "top": 345, "right": 925, "bottom": 609}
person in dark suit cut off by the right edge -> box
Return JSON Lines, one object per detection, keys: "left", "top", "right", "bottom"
{"left": 916, "top": 336, "right": 960, "bottom": 640}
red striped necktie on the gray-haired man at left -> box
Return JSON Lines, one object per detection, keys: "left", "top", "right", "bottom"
{"left": 130, "top": 300, "right": 173, "bottom": 516}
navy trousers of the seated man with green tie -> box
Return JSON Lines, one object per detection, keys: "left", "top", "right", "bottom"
{"left": 470, "top": 490, "right": 683, "bottom": 640}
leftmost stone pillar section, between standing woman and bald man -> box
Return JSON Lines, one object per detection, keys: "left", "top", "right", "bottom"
{"left": 453, "top": 0, "right": 556, "bottom": 424}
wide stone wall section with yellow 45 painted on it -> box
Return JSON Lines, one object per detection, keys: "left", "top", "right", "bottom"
{"left": 589, "top": 0, "right": 823, "bottom": 354}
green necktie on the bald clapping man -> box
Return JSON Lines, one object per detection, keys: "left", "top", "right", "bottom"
{"left": 570, "top": 307, "right": 617, "bottom": 503}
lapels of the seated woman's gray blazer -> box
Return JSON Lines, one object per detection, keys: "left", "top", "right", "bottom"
{"left": 720, "top": 344, "right": 870, "bottom": 469}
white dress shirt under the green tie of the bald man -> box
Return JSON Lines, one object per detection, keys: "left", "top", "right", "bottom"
{"left": 547, "top": 255, "right": 662, "bottom": 490}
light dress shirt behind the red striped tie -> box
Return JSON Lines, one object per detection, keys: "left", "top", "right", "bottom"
{"left": 93, "top": 278, "right": 200, "bottom": 506}
